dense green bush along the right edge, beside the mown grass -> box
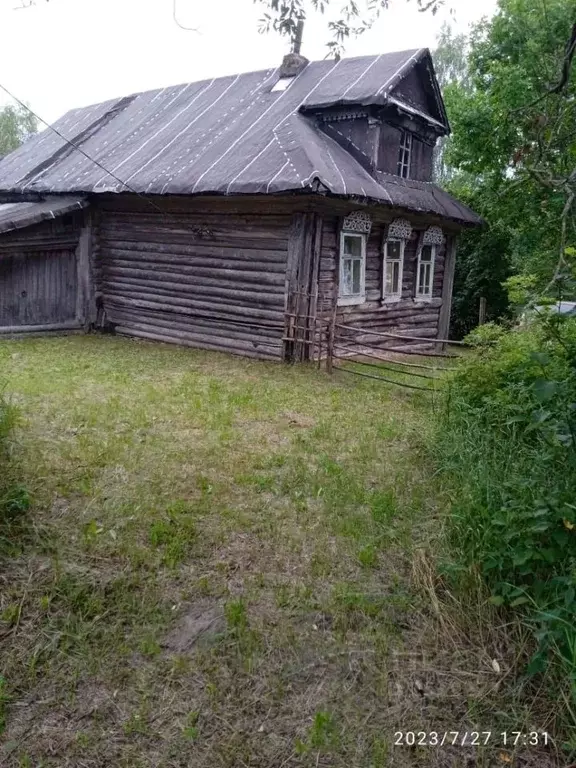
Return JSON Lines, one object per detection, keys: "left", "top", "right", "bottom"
{"left": 436, "top": 316, "right": 576, "bottom": 748}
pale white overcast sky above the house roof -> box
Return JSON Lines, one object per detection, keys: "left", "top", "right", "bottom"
{"left": 0, "top": 0, "right": 496, "bottom": 121}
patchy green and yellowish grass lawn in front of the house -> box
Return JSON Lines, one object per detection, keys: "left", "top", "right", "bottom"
{"left": 0, "top": 336, "right": 551, "bottom": 768}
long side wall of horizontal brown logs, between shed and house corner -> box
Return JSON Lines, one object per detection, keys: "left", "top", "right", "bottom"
{"left": 93, "top": 198, "right": 292, "bottom": 359}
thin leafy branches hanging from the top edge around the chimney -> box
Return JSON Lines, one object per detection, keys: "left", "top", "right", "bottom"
{"left": 254, "top": 0, "right": 445, "bottom": 58}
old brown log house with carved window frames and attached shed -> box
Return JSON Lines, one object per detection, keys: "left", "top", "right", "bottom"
{"left": 0, "top": 49, "right": 480, "bottom": 359}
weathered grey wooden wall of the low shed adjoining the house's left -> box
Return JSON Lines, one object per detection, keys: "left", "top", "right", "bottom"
{"left": 0, "top": 214, "right": 82, "bottom": 334}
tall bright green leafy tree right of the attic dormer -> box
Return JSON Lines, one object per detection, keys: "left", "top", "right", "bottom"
{"left": 448, "top": 0, "right": 576, "bottom": 287}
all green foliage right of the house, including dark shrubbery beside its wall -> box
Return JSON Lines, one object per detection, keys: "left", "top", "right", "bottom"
{"left": 436, "top": 0, "right": 576, "bottom": 337}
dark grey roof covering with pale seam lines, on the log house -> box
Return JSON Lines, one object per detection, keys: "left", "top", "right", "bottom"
{"left": 0, "top": 49, "right": 478, "bottom": 223}
